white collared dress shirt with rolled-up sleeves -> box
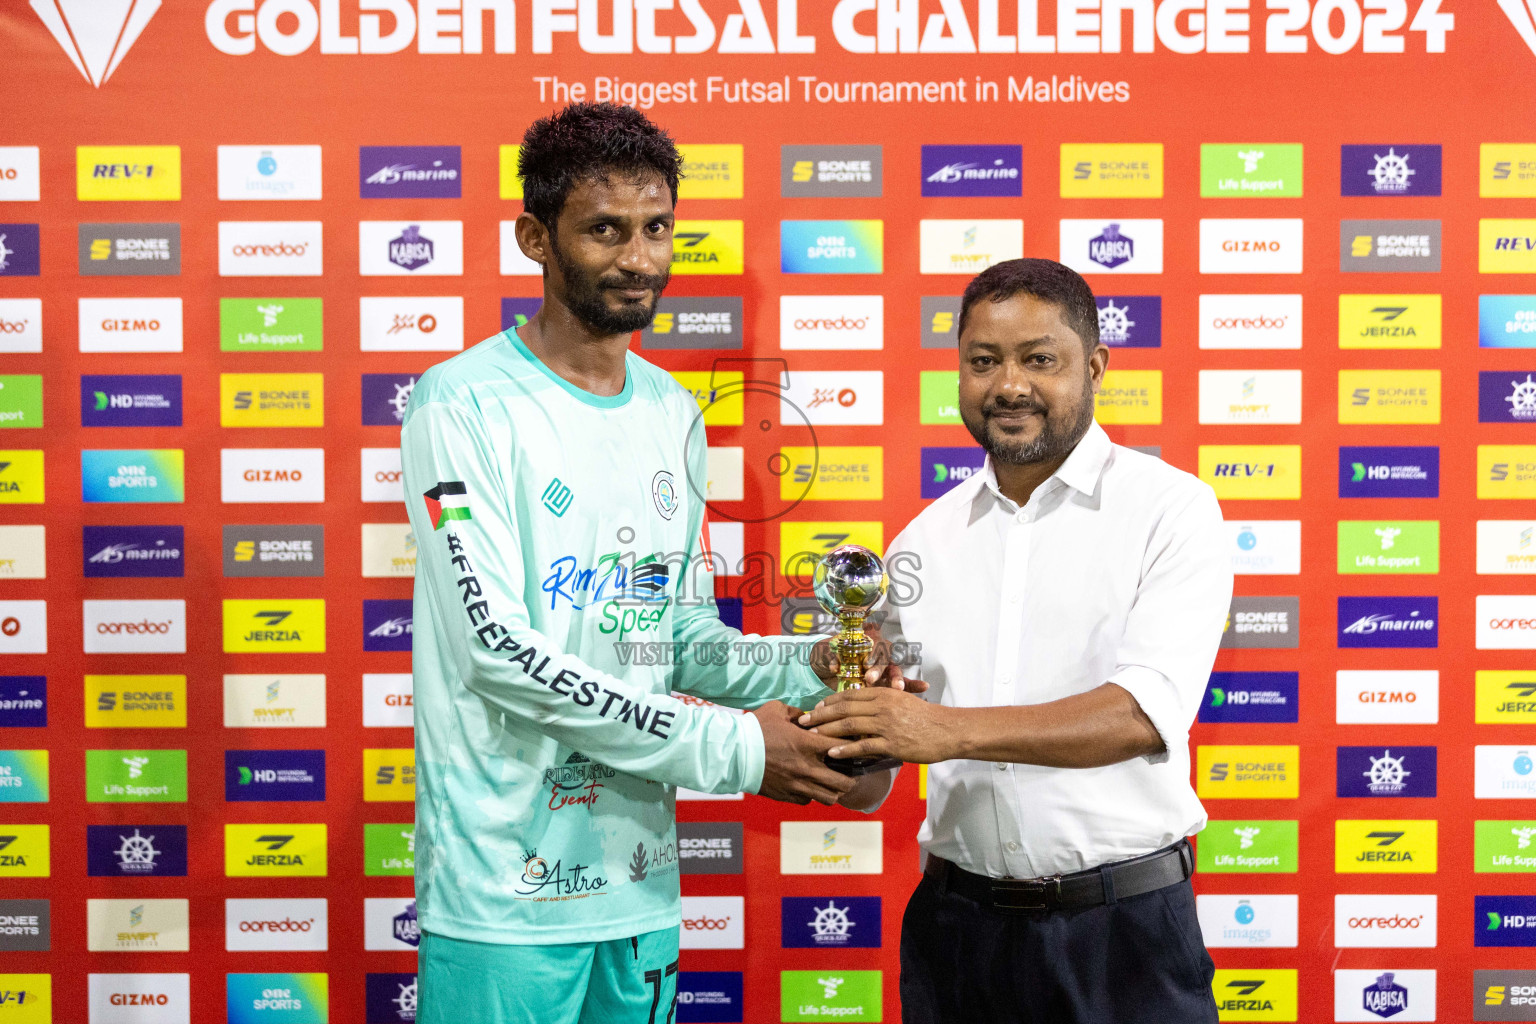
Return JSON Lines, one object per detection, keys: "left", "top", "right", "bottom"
{"left": 883, "top": 422, "right": 1232, "bottom": 878}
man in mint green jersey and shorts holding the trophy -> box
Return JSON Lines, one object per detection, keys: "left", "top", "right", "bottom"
{"left": 401, "top": 104, "right": 917, "bottom": 1024}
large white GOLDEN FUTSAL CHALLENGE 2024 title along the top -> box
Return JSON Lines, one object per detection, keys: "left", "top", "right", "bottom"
{"left": 203, "top": 0, "right": 1456, "bottom": 57}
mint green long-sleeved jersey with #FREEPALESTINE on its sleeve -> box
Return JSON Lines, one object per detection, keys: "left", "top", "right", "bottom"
{"left": 401, "top": 330, "right": 829, "bottom": 944}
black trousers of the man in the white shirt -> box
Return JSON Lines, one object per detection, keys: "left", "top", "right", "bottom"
{"left": 902, "top": 875, "right": 1217, "bottom": 1024}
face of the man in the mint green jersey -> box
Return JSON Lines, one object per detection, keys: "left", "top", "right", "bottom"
{"left": 547, "top": 173, "right": 673, "bottom": 335}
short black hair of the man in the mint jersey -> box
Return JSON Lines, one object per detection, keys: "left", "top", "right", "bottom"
{"left": 518, "top": 103, "right": 682, "bottom": 232}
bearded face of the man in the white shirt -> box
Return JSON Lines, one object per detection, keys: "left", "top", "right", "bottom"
{"left": 960, "top": 295, "right": 1109, "bottom": 465}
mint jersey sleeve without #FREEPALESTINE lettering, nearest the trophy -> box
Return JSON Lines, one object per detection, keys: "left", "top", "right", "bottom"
{"left": 660, "top": 417, "right": 833, "bottom": 708}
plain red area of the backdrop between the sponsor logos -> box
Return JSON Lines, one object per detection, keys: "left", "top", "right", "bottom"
{"left": 0, "top": 0, "right": 1536, "bottom": 1021}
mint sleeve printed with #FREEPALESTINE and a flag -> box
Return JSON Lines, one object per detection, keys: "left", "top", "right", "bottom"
{"left": 401, "top": 401, "right": 763, "bottom": 792}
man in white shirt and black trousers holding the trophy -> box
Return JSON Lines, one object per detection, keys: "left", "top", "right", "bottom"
{"left": 800, "top": 259, "right": 1232, "bottom": 1024}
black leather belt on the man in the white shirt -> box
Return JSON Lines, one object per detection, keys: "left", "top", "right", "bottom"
{"left": 923, "top": 840, "right": 1195, "bottom": 913}
